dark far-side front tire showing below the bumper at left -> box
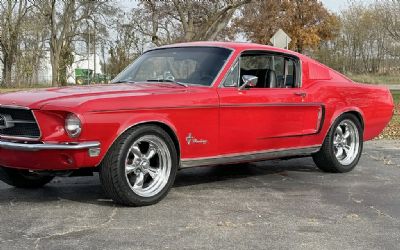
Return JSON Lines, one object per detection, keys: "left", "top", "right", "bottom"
{"left": 0, "top": 167, "right": 54, "bottom": 189}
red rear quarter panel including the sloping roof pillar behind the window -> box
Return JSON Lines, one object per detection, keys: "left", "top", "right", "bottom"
{"left": 299, "top": 55, "right": 394, "bottom": 144}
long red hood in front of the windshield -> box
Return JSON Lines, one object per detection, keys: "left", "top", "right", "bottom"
{"left": 0, "top": 83, "right": 191, "bottom": 110}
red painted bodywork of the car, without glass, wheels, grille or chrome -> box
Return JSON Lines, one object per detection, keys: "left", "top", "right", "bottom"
{"left": 0, "top": 42, "right": 393, "bottom": 170}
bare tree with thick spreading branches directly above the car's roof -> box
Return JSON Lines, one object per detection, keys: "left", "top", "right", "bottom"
{"left": 132, "top": 0, "right": 251, "bottom": 46}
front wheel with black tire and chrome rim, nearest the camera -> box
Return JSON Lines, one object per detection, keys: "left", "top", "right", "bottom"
{"left": 100, "top": 125, "right": 178, "bottom": 206}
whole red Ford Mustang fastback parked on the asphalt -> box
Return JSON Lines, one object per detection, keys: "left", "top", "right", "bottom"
{"left": 0, "top": 42, "right": 393, "bottom": 206}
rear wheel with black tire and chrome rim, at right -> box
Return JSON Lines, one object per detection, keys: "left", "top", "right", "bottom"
{"left": 313, "top": 114, "right": 363, "bottom": 173}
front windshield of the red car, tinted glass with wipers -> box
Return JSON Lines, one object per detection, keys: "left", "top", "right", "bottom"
{"left": 112, "top": 47, "right": 231, "bottom": 86}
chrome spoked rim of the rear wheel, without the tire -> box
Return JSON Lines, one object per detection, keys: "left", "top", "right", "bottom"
{"left": 333, "top": 119, "right": 360, "bottom": 165}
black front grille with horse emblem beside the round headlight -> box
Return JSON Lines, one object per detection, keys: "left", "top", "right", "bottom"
{"left": 0, "top": 107, "right": 40, "bottom": 139}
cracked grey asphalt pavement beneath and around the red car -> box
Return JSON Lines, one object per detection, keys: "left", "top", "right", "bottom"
{"left": 0, "top": 141, "right": 400, "bottom": 249}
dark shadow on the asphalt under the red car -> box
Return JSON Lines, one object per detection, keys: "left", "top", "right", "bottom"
{"left": 0, "top": 158, "right": 320, "bottom": 206}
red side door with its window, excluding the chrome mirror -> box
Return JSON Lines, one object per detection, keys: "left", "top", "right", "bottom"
{"left": 218, "top": 51, "right": 324, "bottom": 154}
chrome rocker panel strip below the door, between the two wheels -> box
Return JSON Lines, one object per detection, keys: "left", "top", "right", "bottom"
{"left": 181, "top": 145, "right": 321, "bottom": 168}
